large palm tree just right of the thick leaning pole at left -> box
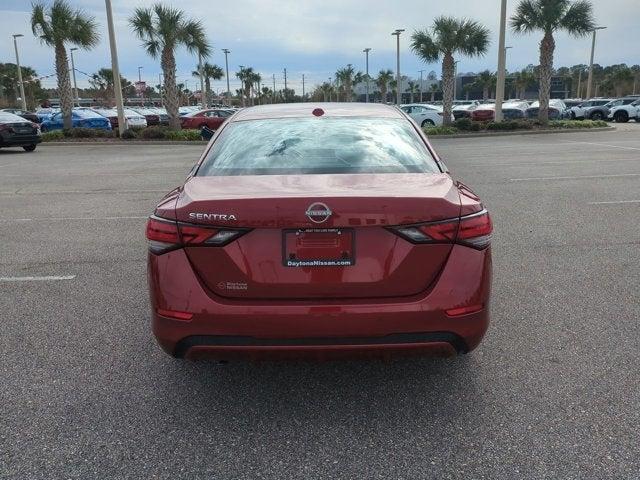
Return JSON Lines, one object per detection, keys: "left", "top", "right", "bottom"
{"left": 129, "top": 3, "right": 211, "bottom": 130}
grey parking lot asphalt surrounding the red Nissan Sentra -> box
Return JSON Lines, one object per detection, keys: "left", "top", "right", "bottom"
{"left": 0, "top": 123, "right": 640, "bottom": 479}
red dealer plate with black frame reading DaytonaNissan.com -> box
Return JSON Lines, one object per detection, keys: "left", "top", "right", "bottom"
{"left": 282, "top": 228, "right": 356, "bottom": 268}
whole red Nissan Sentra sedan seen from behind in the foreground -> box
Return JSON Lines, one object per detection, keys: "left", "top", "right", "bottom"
{"left": 146, "top": 103, "right": 492, "bottom": 359}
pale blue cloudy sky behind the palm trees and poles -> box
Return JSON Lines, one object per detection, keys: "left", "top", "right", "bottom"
{"left": 0, "top": 0, "right": 640, "bottom": 93}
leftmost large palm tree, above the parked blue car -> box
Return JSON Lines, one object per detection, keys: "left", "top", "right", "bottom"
{"left": 31, "top": 0, "right": 100, "bottom": 128}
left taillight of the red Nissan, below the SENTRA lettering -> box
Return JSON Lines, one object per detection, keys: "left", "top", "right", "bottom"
{"left": 147, "top": 215, "right": 247, "bottom": 254}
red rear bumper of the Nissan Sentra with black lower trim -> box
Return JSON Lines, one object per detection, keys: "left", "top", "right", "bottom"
{"left": 148, "top": 245, "right": 491, "bottom": 359}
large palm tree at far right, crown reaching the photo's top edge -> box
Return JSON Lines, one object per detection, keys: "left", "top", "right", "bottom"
{"left": 510, "top": 0, "right": 595, "bottom": 125}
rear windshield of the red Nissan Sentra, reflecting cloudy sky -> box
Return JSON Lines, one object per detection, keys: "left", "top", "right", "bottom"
{"left": 197, "top": 117, "right": 440, "bottom": 176}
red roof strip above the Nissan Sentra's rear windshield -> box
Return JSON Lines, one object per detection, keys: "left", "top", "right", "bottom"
{"left": 231, "top": 102, "right": 405, "bottom": 122}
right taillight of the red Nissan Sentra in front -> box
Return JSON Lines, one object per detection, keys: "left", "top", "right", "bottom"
{"left": 390, "top": 210, "right": 493, "bottom": 250}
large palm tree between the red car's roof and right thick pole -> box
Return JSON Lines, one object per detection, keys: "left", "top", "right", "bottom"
{"left": 411, "top": 17, "right": 489, "bottom": 125}
